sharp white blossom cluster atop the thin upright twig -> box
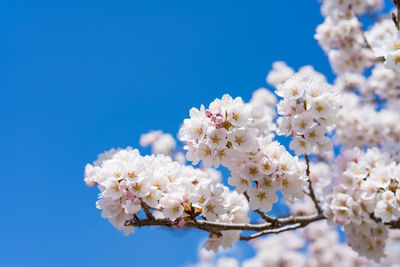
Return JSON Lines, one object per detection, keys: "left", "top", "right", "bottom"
{"left": 276, "top": 74, "right": 339, "bottom": 155}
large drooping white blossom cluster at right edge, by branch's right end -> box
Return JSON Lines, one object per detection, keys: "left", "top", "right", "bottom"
{"left": 324, "top": 148, "right": 400, "bottom": 261}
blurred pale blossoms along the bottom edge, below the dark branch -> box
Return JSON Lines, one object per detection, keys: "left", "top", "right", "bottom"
{"left": 189, "top": 222, "right": 400, "bottom": 267}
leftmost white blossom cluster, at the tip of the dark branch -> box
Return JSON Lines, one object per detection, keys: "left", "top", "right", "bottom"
{"left": 85, "top": 148, "right": 249, "bottom": 249}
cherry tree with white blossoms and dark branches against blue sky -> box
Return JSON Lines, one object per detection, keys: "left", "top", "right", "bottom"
{"left": 84, "top": 0, "right": 400, "bottom": 267}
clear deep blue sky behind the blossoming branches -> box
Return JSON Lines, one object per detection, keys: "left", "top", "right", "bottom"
{"left": 0, "top": 0, "right": 340, "bottom": 267}
